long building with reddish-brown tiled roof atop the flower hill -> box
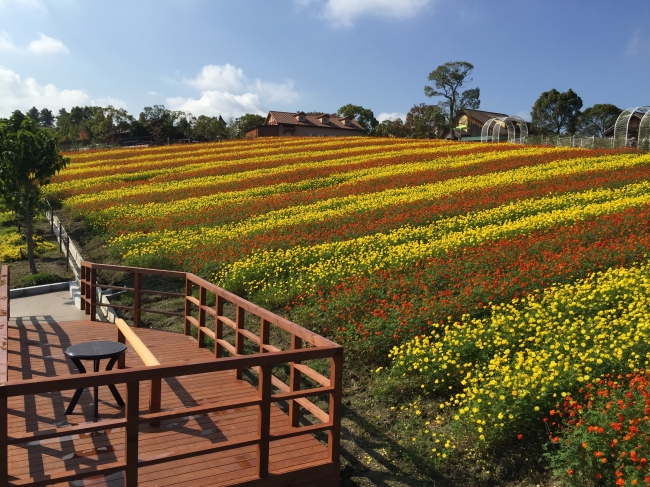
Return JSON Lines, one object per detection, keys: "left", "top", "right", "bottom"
{"left": 246, "top": 111, "right": 364, "bottom": 139}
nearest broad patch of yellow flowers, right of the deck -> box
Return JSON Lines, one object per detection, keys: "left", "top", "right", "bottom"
{"left": 388, "top": 263, "right": 650, "bottom": 441}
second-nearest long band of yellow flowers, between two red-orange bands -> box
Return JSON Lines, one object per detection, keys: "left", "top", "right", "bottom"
{"left": 215, "top": 163, "right": 650, "bottom": 295}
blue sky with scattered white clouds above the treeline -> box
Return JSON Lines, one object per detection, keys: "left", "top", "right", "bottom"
{"left": 0, "top": 0, "right": 650, "bottom": 119}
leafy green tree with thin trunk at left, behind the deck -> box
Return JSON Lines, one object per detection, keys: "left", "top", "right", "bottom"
{"left": 0, "top": 111, "right": 67, "bottom": 274}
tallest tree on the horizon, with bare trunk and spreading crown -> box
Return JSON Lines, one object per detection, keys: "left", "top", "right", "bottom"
{"left": 424, "top": 61, "right": 481, "bottom": 138}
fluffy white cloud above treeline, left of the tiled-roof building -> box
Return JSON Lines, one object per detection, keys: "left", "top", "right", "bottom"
{"left": 166, "top": 64, "right": 300, "bottom": 118}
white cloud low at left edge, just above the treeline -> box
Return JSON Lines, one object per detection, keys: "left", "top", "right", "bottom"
{"left": 0, "top": 66, "right": 126, "bottom": 117}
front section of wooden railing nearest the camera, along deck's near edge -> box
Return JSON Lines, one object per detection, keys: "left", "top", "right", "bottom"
{"left": 0, "top": 346, "right": 343, "bottom": 487}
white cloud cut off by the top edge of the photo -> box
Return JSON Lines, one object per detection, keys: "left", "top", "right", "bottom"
{"left": 295, "top": 0, "right": 431, "bottom": 27}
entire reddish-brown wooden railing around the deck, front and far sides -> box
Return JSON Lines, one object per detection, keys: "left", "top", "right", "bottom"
{"left": 0, "top": 262, "right": 343, "bottom": 487}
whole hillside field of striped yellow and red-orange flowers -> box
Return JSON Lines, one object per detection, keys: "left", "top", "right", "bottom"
{"left": 47, "top": 137, "right": 650, "bottom": 485}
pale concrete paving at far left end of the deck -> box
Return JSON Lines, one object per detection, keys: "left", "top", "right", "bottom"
{"left": 9, "top": 291, "right": 90, "bottom": 321}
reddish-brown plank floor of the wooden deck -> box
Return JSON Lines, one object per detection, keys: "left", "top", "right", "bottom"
{"left": 8, "top": 319, "right": 339, "bottom": 486}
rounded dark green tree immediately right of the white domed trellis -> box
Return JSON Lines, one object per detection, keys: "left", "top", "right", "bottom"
{"left": 530, "top": 88, "right": 582, "bottom": 135}
